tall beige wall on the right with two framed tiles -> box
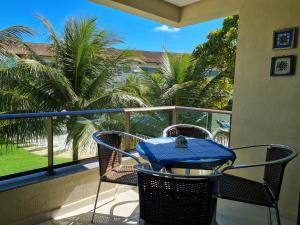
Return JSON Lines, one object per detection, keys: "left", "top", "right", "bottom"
{"left": 232, "top": 0, "right": 300, "bottom": 214}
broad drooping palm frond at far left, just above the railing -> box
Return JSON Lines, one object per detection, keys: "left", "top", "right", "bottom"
{"left": 0, "top": 59, "right": 78, "bottom": 111}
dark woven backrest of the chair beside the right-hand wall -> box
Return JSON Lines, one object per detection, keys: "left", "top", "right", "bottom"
{"left": 264, "top": 145, "right": 293, "bottom": 201}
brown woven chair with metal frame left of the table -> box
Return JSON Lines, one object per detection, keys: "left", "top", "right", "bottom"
{"left": 92, "top": 131, "right": 143, "bottom": 223}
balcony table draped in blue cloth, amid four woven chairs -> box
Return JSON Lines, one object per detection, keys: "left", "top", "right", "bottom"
{"left": 136, "top": 137, "right": 236, "bottom": 225}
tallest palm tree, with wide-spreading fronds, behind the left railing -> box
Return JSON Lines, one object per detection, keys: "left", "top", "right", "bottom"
{"left": 0, "top": 16, "right": 144, "bottom": 160}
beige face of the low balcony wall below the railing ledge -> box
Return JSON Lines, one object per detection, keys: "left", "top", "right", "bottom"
{"left": 0, "top": 169, "right": 99, "bottom": 225}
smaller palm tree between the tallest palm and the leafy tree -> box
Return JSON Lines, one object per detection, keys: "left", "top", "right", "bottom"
{"left": 118, "top": 51, "right": 205, "bottom": 136}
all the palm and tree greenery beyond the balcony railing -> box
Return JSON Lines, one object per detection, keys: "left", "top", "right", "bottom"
{"left": 0, "top": 16, "right": 238, "bottom": 153}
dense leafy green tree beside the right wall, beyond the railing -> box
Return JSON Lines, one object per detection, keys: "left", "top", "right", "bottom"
{"left": 193, "top": 16, "right": 239, "bottom": 110}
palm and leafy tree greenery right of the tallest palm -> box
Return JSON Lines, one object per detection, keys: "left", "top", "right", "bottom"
{"left": 123, "top": 16, "right": 238, "bottom": 136}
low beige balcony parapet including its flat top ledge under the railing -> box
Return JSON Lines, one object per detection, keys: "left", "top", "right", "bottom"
{"left": 0, "top": 159, "right": 136, "bottom": 225}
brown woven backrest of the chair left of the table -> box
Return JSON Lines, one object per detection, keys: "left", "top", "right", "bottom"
{"left": 97, "top": 133, "right": 122, "bottom": 175}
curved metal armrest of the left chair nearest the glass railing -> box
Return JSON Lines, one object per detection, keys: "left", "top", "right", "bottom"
{"left": 93, "top": 131, "right": 144, "bottom": 164}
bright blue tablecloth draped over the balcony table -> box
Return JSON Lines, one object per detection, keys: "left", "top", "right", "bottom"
{"left": 136, "top": 137, "right": 236, "bottom": 171}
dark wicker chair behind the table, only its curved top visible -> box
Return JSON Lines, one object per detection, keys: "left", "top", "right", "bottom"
{"left": 163, "top": 124, "right": 213, "bottom": 139}
